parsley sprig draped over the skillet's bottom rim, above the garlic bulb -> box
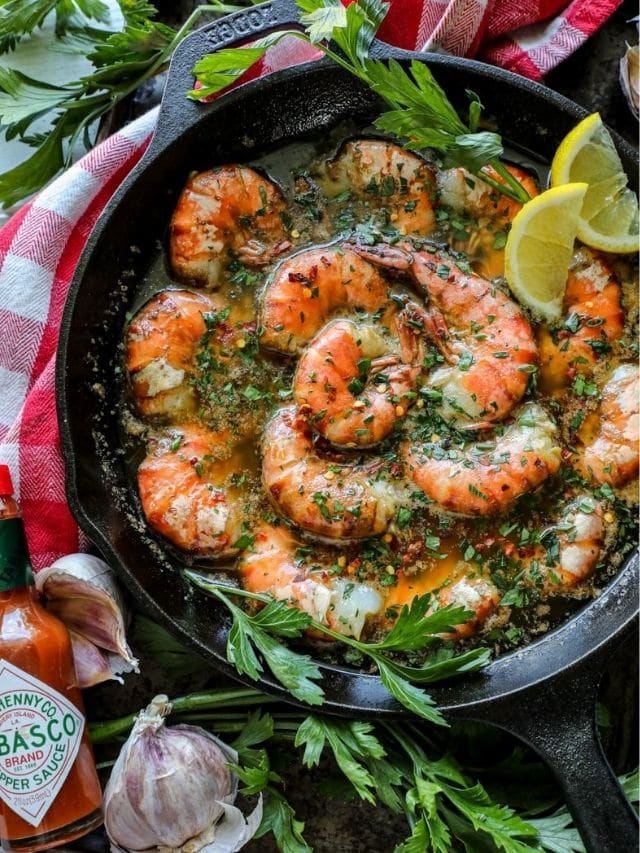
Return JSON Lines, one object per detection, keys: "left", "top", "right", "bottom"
{"left": 185, "top": 570, "right": 490, "bottom": 726}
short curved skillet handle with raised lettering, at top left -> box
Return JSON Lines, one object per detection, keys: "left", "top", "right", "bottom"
{"left": 145, "top": 0, "right": 300, "bottom": 159}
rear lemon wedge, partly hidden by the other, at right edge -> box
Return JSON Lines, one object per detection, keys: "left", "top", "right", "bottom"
{"left": 551, "top": 113, "right": 639, "bottom": 253}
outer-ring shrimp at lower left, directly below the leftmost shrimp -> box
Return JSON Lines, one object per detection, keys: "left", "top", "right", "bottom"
{"left": 138, "top": 424, "right": 246, "bottom": 556}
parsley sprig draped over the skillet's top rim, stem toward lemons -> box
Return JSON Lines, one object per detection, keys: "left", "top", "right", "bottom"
{"left": 188, "top": 0, "right": 529, "bottom": 202}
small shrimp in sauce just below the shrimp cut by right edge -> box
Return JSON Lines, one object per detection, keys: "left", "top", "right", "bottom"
{"left": 526, "top": 495, "right": 605, "bottom": 596}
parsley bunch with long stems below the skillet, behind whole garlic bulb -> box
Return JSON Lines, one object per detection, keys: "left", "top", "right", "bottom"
{"left": 91, "top": 684, "right": 638, "bottom": 853}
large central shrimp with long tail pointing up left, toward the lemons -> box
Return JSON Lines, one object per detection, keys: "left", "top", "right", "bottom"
{"left": 356, "top": 243, "right": 538, "bottom": 429}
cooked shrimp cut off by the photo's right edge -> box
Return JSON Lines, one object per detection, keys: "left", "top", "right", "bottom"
{"left": 577, "top": 364, "right": 640, "bottom": 487}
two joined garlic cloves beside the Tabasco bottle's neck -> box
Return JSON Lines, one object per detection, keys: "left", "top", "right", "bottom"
{"left": 36, "top": 554, "right": 138, "bottom": 688}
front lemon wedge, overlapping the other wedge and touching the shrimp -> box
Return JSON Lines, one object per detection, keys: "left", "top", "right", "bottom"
{"left": 504, "top": 183, "right": 587, "bottom": 320}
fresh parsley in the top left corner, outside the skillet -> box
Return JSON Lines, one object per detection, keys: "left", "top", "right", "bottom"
{"left": 0, "top": 0, "right": 245, "bottom": 207}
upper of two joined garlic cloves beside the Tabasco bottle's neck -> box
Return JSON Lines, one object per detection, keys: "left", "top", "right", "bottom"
{"left": 36, "top": 554, "right": 138, "bottom": 672}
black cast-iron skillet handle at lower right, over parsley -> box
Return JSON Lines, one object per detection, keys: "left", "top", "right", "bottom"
{"left": 456, "top": 647, "right": 638, "bottom": 853}
